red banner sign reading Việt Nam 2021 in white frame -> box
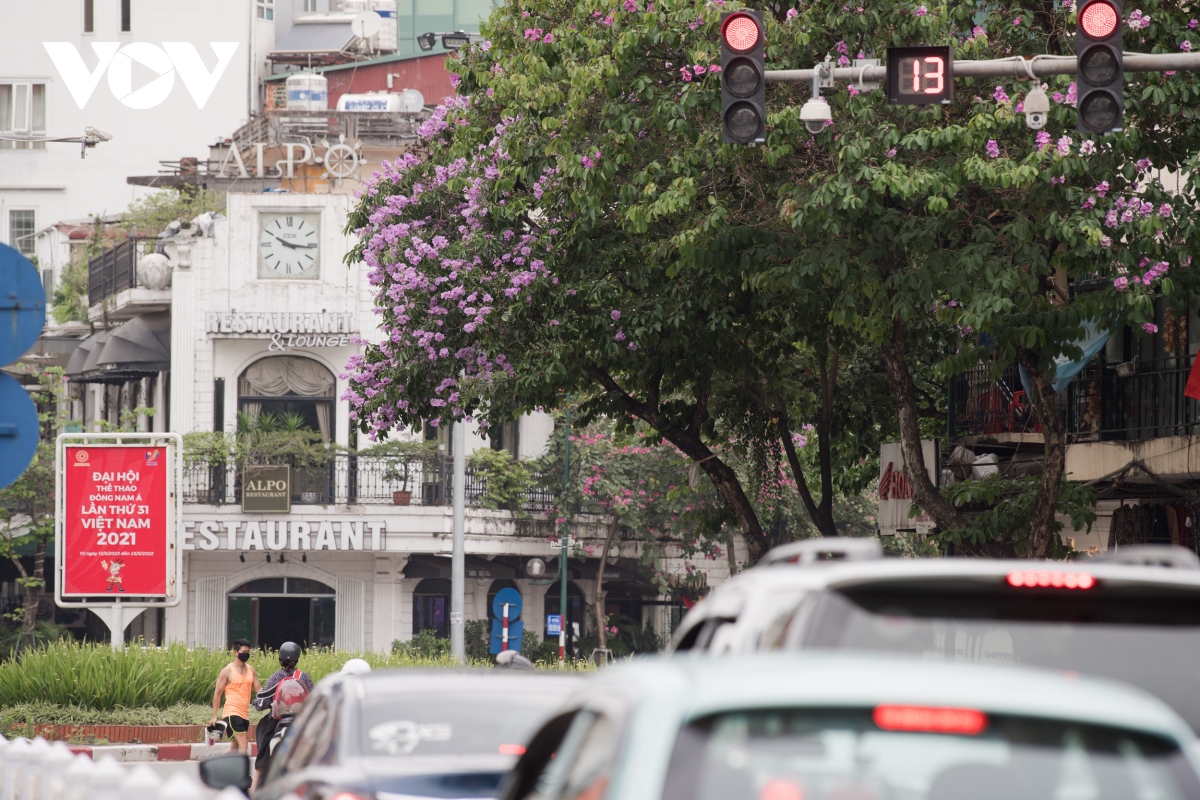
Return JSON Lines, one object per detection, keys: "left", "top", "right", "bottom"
{"left": 62, "top": 445, "right": 170, "bottom": 597}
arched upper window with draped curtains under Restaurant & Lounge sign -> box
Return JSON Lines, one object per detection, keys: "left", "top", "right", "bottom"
{"left": 238, "top": 355, "right": 337, "bottom": 443}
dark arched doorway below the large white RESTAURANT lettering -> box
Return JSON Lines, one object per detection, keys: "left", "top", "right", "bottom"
{"left": 227, "top": 578, "right": 336, "bottom": 649}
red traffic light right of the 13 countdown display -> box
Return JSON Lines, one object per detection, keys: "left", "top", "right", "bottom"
{"left": 1075, "top": 0, "right": 1124, "bottom": 133}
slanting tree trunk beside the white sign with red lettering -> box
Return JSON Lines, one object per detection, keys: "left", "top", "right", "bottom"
{"left": 880, "top": 317, "right": 967, "bottom": 530}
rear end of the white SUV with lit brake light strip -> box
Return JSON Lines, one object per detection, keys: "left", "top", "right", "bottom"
{"left": 768, "top": 547, "right": 1200, "bottom": 730}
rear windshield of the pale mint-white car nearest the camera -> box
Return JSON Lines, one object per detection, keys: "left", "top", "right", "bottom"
{"left": 662, "top": 706, "right": 1200, "bottom": 800}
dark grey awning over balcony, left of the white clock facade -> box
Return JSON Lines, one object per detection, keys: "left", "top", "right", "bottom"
{"left": 65, "top": 313, "right": 170, "bottom": 384}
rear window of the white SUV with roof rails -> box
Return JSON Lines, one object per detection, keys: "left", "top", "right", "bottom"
{"left": 800, "top": 582, "right": 1200, "bottom": 730}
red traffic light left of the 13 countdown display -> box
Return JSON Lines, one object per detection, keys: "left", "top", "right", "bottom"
{"left": 721, "top": 11, "right": 767, "bottom": 144}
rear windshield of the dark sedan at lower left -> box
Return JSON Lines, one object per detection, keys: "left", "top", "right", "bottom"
{"left": 362, "top": 692, "right": 563, "bottom": 757}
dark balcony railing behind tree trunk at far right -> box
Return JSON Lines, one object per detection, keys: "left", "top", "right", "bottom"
{"left": 950, "top": 354, "right": 1200, "bottom": 441}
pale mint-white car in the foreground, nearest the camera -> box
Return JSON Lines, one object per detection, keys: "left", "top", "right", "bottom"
{"left": 500, "top": 654, "right": 1200, "bottom": 800}
